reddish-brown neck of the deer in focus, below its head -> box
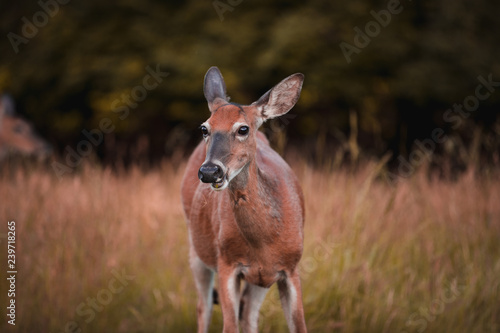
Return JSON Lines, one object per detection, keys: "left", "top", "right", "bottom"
{"left": 228, "top": 161, "right": 281, "bottom": 248}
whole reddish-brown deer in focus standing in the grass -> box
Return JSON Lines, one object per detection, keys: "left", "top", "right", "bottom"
{"left": 181, "top": 67, "right": 307, "bottom": 333}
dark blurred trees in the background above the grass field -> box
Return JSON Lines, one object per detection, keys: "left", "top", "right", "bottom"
{"left": 0, "top": 0, "right": 500, "bottom": 164}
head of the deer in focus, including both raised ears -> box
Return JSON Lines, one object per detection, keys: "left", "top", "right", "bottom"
{"left": 198, "top": 67, "right": 304, "bottom": 190}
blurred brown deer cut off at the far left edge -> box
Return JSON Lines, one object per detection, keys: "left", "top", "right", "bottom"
{"left": 0, "top": 95, "right": 52, "bottom": 160}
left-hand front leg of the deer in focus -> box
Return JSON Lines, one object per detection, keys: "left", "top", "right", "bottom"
{"left": 218, "top": 259, "right": 240, "bottom": 333}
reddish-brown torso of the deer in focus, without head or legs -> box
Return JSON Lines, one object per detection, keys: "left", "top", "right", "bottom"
{"left": 183, "top": 132, "right": 304, "bottom": 282}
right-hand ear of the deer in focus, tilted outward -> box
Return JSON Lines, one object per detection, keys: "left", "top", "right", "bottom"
{"left": 252, "top": 73, "right": 304, "bottom": 120}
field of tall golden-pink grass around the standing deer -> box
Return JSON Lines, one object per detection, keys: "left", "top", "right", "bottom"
{"left": 0, "top": 159, "right": 500, "bottom": 333}
